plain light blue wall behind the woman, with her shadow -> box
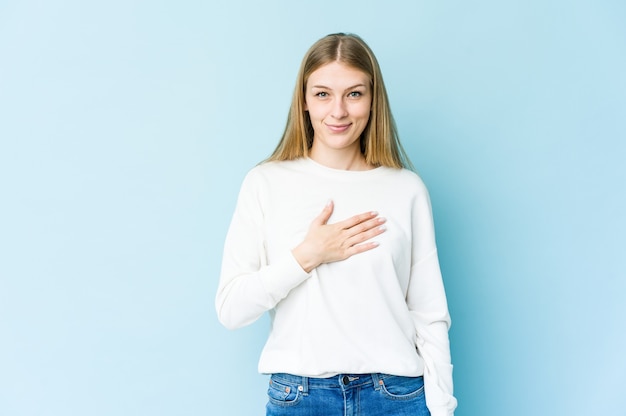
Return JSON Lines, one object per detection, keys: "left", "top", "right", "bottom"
{"left": 0, "top": 0, "right": 626, "bottom": 416}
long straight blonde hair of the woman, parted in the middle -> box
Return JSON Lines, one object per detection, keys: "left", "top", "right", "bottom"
{"left": 267, "top": 33, "right": 413, "bottom": 169}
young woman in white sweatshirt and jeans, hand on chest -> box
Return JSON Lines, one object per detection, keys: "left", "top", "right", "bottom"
{"left": 216, "top": 34, "right": 456, "bottom": 416}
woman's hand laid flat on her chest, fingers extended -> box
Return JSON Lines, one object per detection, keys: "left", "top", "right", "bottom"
{"left": 292, "top": 201, "right": 385, "bottom": 273}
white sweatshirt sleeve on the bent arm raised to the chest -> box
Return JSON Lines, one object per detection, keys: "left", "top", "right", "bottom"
{"left": 215, "top": 170, "right": 310, "bottom": 329}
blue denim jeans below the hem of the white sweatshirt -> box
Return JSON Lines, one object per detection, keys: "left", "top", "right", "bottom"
{"left": 266, "top": 374, "right": 430, "bottom": 416}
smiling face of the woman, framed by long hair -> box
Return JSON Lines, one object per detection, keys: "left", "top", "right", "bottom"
{"left": 305, "top": 62, "right": 372, "bottom": 156}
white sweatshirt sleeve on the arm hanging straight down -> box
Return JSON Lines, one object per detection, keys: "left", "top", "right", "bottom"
{"left": 407, "top": 184, "right": 457, "bottom": 416}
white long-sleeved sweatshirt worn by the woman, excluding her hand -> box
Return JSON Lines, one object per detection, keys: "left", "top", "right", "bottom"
{"left": 216, "top": 158, "right": 456, "bottom": 416}
